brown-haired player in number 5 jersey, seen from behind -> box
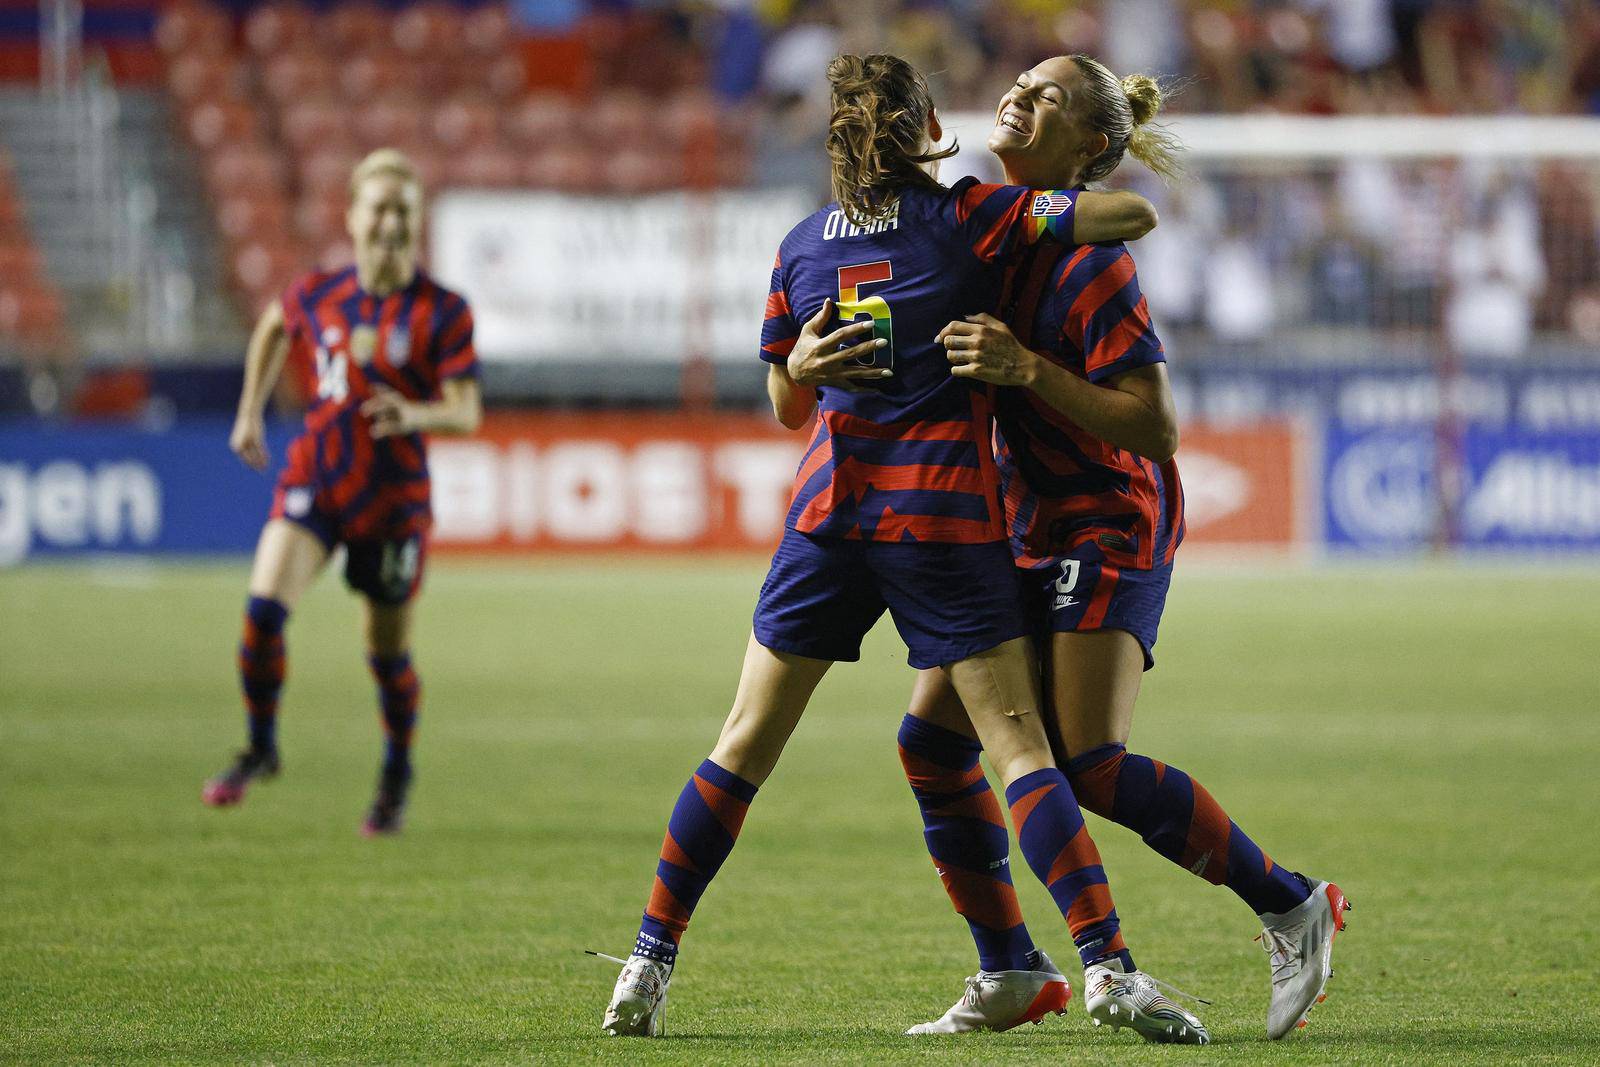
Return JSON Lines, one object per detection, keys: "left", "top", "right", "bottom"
{"left": 603, "top": 56, "right": 1171, "bottom": 1035}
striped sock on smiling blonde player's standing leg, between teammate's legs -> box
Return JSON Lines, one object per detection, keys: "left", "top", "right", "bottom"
{"left": 899, "top": 715, "right": 1034, "bottom": 971}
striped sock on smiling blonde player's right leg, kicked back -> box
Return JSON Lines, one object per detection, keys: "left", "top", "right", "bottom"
{"left": 1067, "top": 744, "right": 1310, "bottom": 915}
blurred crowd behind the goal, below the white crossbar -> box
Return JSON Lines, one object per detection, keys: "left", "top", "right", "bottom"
{"left": 1136, "top": 160, "right": 1600, "bottom": 358}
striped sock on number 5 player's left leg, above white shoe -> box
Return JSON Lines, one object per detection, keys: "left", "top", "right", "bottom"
{"left": 634, "top": 760, "right": 755, "bottom": 963}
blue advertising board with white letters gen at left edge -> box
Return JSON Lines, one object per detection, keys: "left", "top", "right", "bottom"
{"left": 0, "top": 419, "right": 293, "bottom": 565}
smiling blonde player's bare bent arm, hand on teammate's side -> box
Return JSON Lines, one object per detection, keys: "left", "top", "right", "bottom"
{"left": 938, "top": 308, "right": 1178, "bottom": 462}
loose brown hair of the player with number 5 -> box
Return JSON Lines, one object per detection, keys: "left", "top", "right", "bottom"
{"left": 827, "top": 54, "right": 957, "bottom": 226}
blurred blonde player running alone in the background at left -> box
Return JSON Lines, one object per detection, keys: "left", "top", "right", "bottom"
{"left": 202, "top": 149, "right": 482, "bottom": 833}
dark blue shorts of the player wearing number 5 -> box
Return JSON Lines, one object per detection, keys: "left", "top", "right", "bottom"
{"left": 755, "top": 530, "right": 1030, "bottom": 669}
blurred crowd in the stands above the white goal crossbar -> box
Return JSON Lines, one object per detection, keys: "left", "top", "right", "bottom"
{"left": 556, "top": 0, "right": 1600, "bottom": 114}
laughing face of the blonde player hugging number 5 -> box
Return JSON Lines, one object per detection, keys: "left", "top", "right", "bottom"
{"left": 989, "top": 56, "right": 1107, "bottom": 187}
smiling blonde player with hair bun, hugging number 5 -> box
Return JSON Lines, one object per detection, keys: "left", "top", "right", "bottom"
{"left": 899, "top": 56, "right": 1349, "bottom": 1040}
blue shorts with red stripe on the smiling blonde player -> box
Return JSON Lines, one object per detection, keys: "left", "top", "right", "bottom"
{"left": 1018, "top": 544, "right": 1173, "bottom": 670}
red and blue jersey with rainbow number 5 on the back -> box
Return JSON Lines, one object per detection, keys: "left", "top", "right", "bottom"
{"left": 762, "top": 178, "right": 1077, "bottom": 544}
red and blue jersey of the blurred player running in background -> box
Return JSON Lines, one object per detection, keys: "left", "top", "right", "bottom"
{"left": 282, "top": 266, "right": 478, "bottom": 537}
